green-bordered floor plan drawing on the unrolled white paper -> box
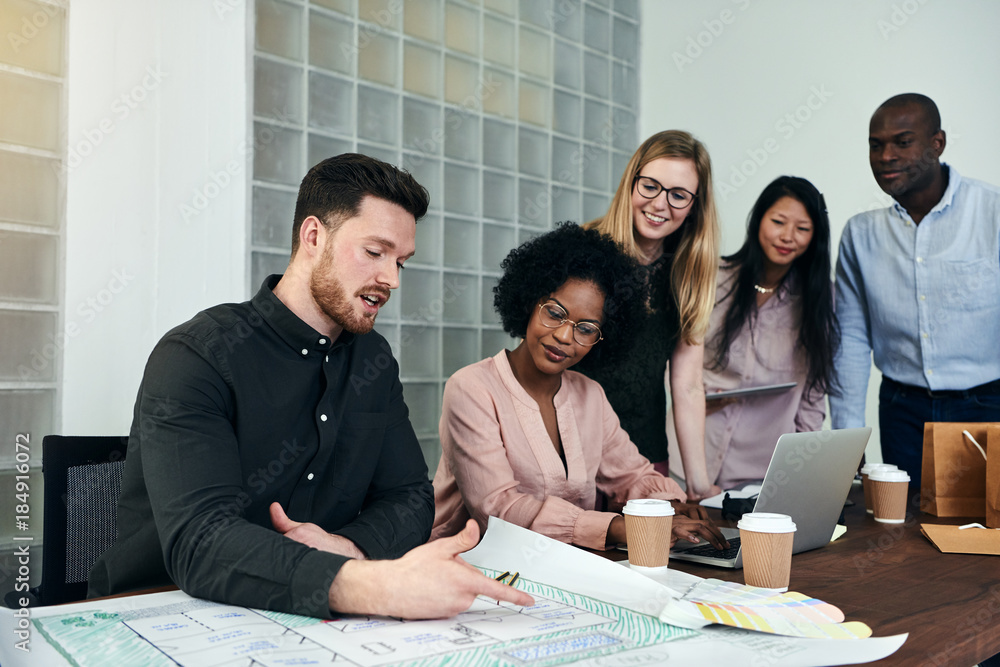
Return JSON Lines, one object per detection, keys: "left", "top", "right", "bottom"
{"left": 29, "top": 571, "right": 697, "bottom": 667}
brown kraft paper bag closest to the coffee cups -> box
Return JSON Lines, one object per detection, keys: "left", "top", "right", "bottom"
{"left": 920, "top": 422, "right": 1000, "bottom": 517}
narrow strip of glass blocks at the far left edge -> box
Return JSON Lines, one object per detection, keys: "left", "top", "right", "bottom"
{"left": 0, "top": 0, "right": 66, "bottom": 591}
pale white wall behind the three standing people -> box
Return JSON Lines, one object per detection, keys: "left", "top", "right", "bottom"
{"left": 640, "top": 0, "right": 1000, "bottom": 458}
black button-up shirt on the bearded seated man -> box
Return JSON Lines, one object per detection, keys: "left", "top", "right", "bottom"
{"left": 90, "top": 276, "right": 434, "bottom": 617}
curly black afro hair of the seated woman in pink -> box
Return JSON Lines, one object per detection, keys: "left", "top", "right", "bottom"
{"left": 493, "top": 222, "right": 645, "bottom": 367}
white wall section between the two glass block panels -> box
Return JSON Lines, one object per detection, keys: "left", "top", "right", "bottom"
{"left": 60, "top": 0, "right": 251, "bottom": 435}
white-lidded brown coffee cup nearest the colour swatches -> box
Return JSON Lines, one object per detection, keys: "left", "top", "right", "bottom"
{"left": 736, "top": 512, "right": 795, "bottom": 590}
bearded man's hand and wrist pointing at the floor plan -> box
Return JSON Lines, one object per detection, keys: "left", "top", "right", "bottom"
{"left": 330, "top": 520, "right": 535, "bottom": 619}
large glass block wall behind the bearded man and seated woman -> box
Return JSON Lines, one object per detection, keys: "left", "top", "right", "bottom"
{"left": 249, "top": 0, "right": 639, "bottom": 474}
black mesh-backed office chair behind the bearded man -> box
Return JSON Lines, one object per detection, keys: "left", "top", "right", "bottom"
{"left": 4, "top": 435, "right": 128, "bottom": 608}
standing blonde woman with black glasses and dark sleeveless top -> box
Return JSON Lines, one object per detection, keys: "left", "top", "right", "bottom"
{"left": 586, "top": 130, "right": 720, "bottom": 502}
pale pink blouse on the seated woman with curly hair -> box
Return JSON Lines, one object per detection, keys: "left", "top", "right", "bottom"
{"left": 431, "top": 350, "right": 685, "bottom": 549}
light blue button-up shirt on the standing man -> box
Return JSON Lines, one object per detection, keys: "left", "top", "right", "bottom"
{"left": 830, "top": 165, "right": 1000, "bottom": 428}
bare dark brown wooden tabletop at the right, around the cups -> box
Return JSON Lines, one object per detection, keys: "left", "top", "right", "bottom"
{"left": 608, "top": 486, "right": 1000, "bottom": 667}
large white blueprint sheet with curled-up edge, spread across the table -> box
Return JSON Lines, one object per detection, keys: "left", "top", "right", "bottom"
{"left": 0, "top": 521, "right": 905, "bottom": 667}
